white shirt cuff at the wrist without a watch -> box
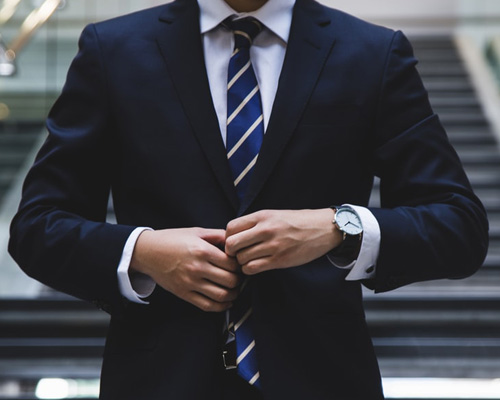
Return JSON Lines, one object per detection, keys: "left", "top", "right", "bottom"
{"left": 117, "top": 228, "right": 156, "bottom": 304}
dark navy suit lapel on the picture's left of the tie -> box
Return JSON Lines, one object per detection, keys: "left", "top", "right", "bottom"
{"left": 157, "top": 0, "right": 238, "bottom": 210}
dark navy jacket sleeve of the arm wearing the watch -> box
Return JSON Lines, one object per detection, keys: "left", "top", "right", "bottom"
{"left": 366, "top": 32, "right": 488, "bottom": 292}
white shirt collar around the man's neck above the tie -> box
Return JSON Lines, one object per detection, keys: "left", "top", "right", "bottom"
{"left": 198, "top": 0, "right": 295, "bottom": 43}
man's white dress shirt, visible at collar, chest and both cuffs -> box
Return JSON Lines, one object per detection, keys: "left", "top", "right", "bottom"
{"left": 118, "top": 0, "right": 380, "bottom": 304}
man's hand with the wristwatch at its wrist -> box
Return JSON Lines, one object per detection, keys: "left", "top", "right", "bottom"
{"left": 226, "top": 208, "right": 342, "bottom": 275}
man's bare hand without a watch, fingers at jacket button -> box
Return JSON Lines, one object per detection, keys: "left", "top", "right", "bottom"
{"left": 130, "top": 228, "right": 241, "bottom": 312}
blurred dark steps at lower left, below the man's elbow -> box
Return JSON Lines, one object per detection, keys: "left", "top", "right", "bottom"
{"left": 0, "top": 295, "right": 102, "bottom": 400}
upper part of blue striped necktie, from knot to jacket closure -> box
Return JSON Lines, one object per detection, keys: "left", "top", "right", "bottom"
{"left": 223, "top": 17, "right": 264, "bottom": 202}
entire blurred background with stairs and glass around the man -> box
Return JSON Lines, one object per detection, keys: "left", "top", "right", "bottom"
{"left": 0, "top": 0, "right": 500, "bottom": 400}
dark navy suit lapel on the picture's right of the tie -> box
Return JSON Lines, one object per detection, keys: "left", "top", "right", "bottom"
{"left": 238, "top": 0, "right": 335, "bottom": 215}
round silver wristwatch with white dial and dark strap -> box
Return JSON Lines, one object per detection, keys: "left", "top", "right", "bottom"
{"left": 329, "top": 206, "right": 363, "bottom": 261}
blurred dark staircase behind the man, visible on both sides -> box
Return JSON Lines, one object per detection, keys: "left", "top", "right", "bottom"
{"left": 0, "top": 37, "right": 500, "bottom": 400}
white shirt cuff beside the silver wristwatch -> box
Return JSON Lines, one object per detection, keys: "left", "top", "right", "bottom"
{"left": 327, "top": 204, "right": 380, "bottom": 281}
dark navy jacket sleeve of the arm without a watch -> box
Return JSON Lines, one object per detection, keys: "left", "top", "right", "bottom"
{"left": 9, "top": 26, "right": 135, "bottom": 312}
